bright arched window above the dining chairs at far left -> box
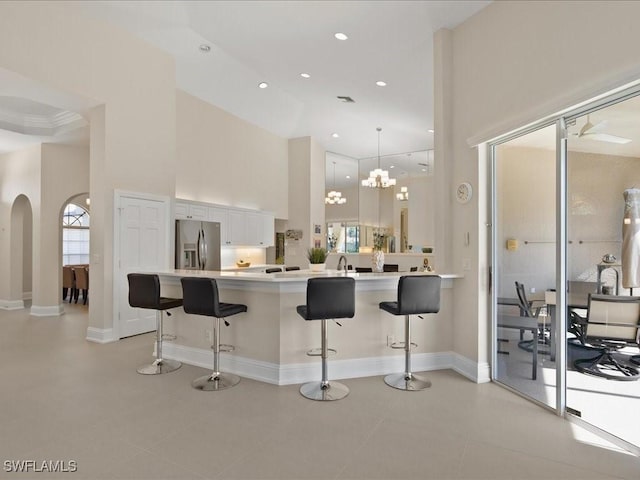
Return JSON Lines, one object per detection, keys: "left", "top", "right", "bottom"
{"left": 62, "top": 203, "right": 89, "bottom": 265}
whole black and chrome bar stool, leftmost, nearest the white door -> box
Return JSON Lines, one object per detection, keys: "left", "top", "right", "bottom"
{"left": 127, "top": 273, "right": 182, "bottom": 375}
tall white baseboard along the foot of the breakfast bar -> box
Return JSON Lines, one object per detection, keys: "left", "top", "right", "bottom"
{"left": 162, "top": 342, "right": 488, "bottom": 385}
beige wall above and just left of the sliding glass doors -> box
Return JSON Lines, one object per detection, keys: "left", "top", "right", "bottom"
{"left": 444, "top": 1, "right": 640, "bottom": 368}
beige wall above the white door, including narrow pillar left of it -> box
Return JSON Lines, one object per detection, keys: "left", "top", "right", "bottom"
{"left": 0, "top": 2, "right": 176, "bottom": 330}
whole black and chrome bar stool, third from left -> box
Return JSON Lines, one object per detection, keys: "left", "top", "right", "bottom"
{"left": 296, "top": 277, "right": 356, "bottom": 401}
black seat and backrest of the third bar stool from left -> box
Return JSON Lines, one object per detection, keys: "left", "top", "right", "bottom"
{"left": 296, "top": 277, "right": 356, "bottom": 320}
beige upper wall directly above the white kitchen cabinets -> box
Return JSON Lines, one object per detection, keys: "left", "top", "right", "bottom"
{"left": 176, "top": 90, "right": 288, "bottom": 218}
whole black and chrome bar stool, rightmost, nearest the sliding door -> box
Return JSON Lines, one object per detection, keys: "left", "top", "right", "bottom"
{"left": 380, "top": 275, "right": 441, "bottom": 390}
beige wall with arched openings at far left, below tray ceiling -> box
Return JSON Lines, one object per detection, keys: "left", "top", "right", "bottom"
{"left": 0, "top": 144, "right": 89, "bottom": 314}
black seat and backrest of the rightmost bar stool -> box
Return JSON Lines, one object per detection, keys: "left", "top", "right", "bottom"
{"left": 380, "top": 275, "right": 442, "bottom": 315}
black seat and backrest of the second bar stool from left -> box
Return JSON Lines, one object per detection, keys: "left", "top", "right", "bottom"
{"left": 180, "top": 277, "right": 247, "bottom": 318}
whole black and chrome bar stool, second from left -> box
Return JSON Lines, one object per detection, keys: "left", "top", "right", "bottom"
{"left": 180, "top": 277, "right": 247, "bottom": 392}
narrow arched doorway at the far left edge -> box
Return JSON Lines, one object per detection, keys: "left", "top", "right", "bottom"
{"left": 7, "top": 194, "right": 33, "bottom": 309}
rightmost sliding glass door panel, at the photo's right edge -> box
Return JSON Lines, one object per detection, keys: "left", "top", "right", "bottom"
{"left": 567, "top": 96, "right": 640, "bottom": 446}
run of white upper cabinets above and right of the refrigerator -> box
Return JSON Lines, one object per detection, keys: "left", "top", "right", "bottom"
{"left": 175, "top": 201, "right": 275, "bottom": 247}
